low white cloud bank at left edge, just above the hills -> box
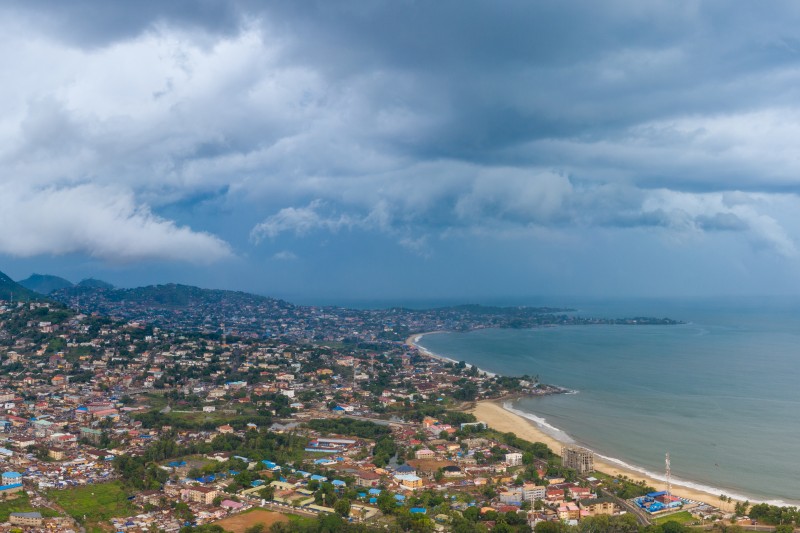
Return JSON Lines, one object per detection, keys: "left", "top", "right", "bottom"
{"left": 0, "top": 184, "right": 232, "bottom": 262}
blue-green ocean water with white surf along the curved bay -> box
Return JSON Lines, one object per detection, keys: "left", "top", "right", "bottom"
{"left": 420, "top": 299, "right": 800, "bottom": 505}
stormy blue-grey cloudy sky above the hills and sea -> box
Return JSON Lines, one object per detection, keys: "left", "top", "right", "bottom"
{"left": 0, "top": 0, "right": 800, "bottom": 303}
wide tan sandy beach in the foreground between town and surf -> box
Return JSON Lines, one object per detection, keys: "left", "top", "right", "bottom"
{"left": 470, "top": 400, "right": 735, "bottom": 511}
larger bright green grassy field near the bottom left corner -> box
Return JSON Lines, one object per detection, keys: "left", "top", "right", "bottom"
{"left": 47, "top": 481, "right": 136, "bottom": 531}
